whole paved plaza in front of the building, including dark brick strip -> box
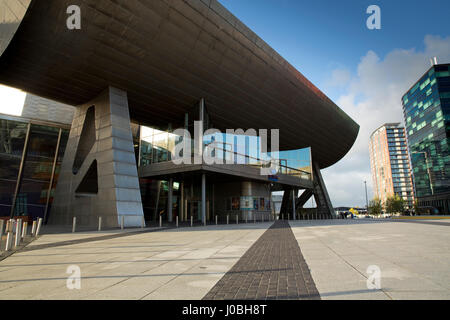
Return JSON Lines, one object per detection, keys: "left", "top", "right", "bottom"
{"left": 0, "top": 219, "right": 450, "bottom": 300}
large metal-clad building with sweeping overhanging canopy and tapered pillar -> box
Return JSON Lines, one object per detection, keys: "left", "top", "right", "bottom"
{"left": 0, "top": 0, "right": 359, "bottom": 227}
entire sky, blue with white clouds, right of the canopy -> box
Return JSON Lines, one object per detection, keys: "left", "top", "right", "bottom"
{"left": 220, "top": 0, "right": 450, "bottom": 206}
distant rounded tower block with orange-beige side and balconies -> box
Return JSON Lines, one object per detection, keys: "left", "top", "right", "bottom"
{"left": 369, "top": 123, "right": 414, "bottom": 210}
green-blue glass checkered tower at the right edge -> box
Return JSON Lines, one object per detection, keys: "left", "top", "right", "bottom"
{"left": 402, "top": 64, "right": 450, "bottom": 213}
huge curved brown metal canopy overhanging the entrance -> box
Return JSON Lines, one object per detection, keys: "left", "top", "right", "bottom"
{"left": 0, "top": 0, "right": 359, "bottom": 168}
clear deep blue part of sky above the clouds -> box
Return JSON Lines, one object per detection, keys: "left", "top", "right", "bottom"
{"left": 220, "top": 0, "right": 450, "bottom": 100}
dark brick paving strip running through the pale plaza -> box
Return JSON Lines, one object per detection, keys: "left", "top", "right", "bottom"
{"left": 203, "top": 220, "right": 320, "bottom": 300}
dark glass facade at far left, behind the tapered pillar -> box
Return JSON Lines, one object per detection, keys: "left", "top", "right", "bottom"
{"left": 0, "top": 118, "right": 69, "bottom": 220}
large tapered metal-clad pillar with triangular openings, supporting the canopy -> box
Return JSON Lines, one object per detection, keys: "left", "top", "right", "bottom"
{"left": 49, "top": 87, "right": 143, "bottom": 227}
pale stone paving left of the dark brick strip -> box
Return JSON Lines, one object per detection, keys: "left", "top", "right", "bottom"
{"left": 0, "top": 223, "right": 271, "bottom": 300}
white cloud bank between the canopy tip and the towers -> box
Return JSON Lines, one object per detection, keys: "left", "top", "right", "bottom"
{"left": 323, "top": 35, "right": 450, "bottom": 206}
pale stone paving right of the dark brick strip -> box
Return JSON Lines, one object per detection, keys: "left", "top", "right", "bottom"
{"left": 290, "top": 219, "right": 450, "bottom": 300}
